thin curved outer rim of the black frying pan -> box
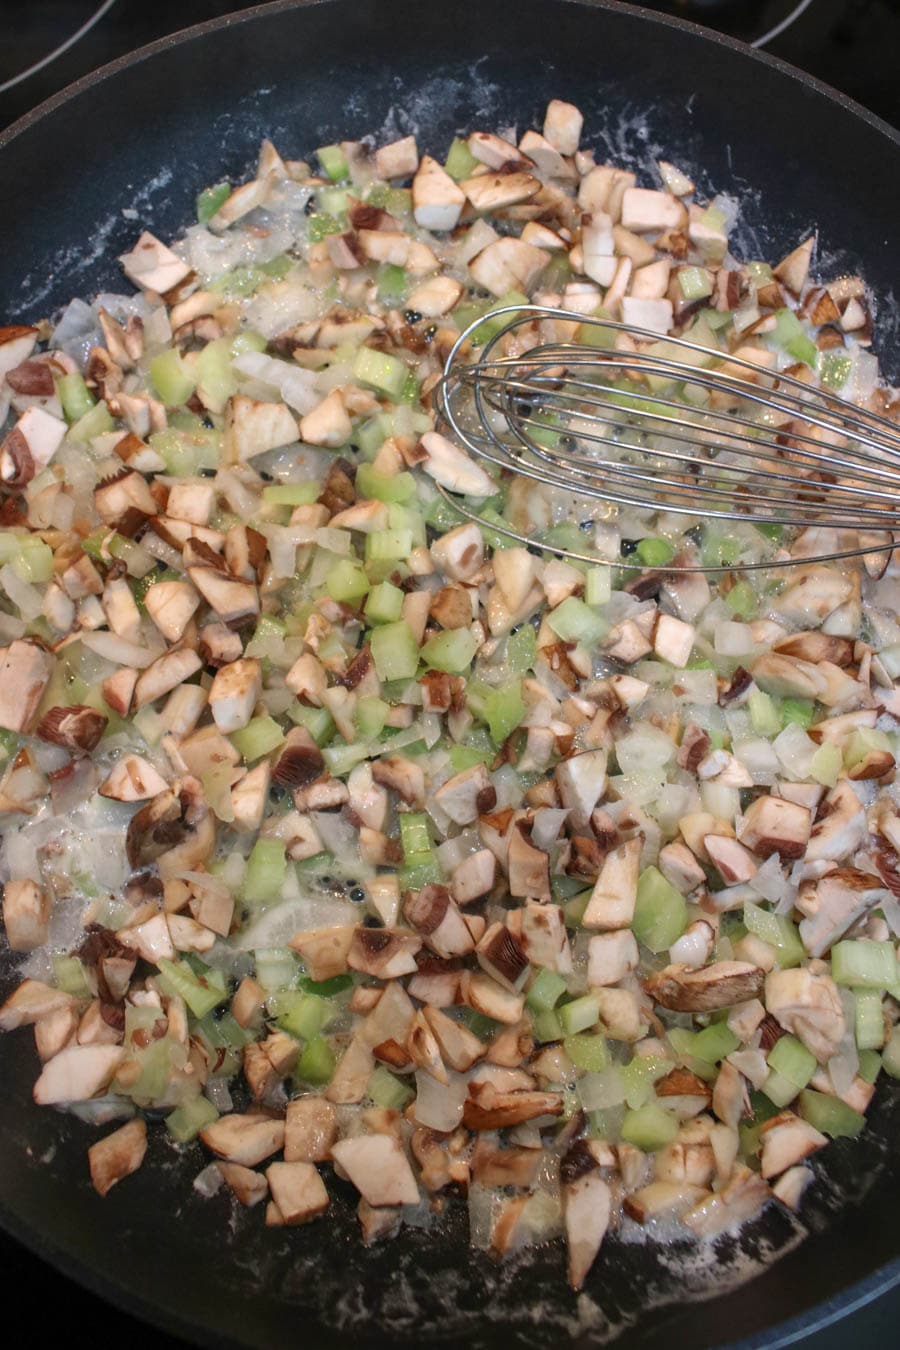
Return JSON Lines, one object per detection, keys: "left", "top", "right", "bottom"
{"left": 0, "top": 0, "right": 900, "bottom": 1350}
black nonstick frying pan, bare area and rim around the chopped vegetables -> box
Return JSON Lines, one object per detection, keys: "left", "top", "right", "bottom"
{"left": 0, "top": 0, "right": 900, "bottom": 1350}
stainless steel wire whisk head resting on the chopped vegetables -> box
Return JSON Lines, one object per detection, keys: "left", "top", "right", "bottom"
{"left": 436, "top": 305, "right": 900, "bottom": 571}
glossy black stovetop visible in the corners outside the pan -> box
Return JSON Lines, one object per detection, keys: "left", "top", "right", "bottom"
{"left": 0, "top": 0, "right": 900, "bottom": 1350}
